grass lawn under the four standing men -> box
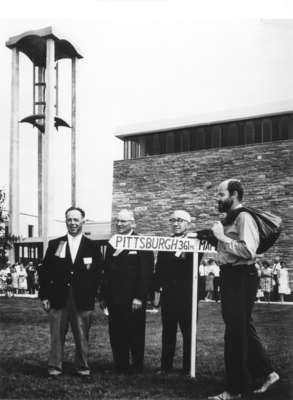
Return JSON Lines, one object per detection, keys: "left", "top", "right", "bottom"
{"left": 0, "top": 298, "right": 293, "bottom": 400}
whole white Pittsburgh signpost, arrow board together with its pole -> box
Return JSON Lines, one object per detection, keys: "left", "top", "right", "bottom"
{"left": 109, "top": 234, "right": 216, "bottom": 378}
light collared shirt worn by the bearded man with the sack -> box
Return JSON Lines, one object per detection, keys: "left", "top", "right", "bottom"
{"left": 216, "top": 205, "right": 259, "bottom": 265}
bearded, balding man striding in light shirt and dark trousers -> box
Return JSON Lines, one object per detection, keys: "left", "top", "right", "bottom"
{"left": 205, "top": 179, "right": 279, "bottom": 400}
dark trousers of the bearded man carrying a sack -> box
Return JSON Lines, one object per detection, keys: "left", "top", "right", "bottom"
{"left": 221, "top": 266, "right": 273, "bottom": 393}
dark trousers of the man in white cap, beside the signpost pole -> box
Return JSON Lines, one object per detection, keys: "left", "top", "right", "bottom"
{"left": 161, "top": 304, "right": 191, "bottom": 373}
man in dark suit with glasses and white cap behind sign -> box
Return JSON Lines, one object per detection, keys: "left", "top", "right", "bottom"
{"left": 154, "top": 210, "right": 193, "bottom": 374}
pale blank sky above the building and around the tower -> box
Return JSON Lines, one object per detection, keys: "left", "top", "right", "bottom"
{"left": 0, "top": 0, "right": 293, "bottom": 234}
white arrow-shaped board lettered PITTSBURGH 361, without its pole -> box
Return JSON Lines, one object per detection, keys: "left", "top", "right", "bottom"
{"left": 109, "top": 235, "right": 216, "bottom": 253}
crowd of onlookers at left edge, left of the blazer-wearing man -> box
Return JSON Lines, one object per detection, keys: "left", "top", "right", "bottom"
{"left": 0, "top": 261, "right": 38, "bottom": 297}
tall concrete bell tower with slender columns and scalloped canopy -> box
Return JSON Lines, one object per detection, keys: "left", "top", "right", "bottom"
{"left": 6, "top": 27, "right": 82, "bottom": 251}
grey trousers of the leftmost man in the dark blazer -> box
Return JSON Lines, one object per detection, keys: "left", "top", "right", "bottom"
{"left": 48, "top": 290, "right": 92, "bottom": 369}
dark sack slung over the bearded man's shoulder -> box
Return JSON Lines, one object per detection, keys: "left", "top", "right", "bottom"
{"left": 225, "top": 207, "right": 282, "bottom": 254}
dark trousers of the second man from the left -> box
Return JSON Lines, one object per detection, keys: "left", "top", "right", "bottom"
{"left": 109, "top": 304, "right": 146, "bottom": 372}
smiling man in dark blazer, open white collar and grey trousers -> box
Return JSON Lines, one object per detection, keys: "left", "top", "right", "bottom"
{"left": 39, "top": 207, "right": 103, "bottom": 376}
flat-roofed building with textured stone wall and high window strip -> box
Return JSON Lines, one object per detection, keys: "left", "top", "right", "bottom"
{"left": 112, "top": 111, "right": 293, "bottom": 287}
